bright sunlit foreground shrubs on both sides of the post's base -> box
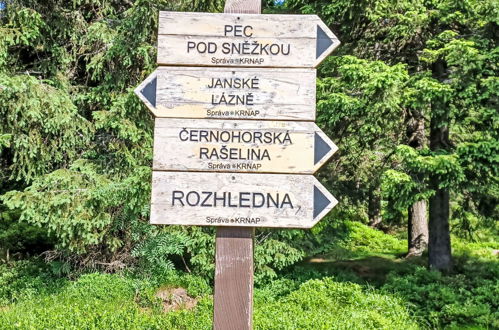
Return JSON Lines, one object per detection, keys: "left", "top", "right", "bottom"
{"left": 0, "top": 273, "right": 416, "bottom": 329}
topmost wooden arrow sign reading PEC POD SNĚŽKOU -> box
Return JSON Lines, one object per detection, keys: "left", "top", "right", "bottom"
{"left": 157, "top": 12, "right": 340, "bottom": 67}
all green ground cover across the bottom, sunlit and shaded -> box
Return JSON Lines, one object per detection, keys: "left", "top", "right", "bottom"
{"left": 0, "top": 223, "right": 499, "bottom": 329}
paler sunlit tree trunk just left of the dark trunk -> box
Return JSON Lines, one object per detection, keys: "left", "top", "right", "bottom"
{"left": 407, "top": 200, "right": 428, "bottom": 257}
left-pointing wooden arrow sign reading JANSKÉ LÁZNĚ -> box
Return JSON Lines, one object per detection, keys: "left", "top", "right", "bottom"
{"left": 135, "top": 67, "right": 316, "bottom": 121}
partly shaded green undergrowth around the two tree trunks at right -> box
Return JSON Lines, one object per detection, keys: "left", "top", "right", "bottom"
{"left": 286, "top": 222, "right": 499, "bottom": 329}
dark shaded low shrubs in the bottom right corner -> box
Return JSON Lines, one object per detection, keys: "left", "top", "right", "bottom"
{"left": 381, "top": 264, "right": 499, "bottom": 329}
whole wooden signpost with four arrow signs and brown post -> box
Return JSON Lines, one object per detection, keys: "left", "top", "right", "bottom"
{"left": 135, "top": 0, "right": 339, "bottom": 329}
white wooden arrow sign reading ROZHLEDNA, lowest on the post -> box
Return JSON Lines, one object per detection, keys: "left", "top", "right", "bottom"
{"left": 151, "top": 171, "right": 337, "bottom": 228}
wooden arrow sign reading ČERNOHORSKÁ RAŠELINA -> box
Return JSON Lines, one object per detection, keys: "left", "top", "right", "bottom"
{"left": 153, "top": 118, "right": 337, "bottom": 174}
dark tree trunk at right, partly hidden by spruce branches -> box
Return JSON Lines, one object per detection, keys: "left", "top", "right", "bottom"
{"left": 428, "top": 61, "right": 452, "bottom": 271}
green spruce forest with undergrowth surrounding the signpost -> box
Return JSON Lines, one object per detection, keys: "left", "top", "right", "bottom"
{"left": 0, "top": 0, "right": 499, "bottom": 329}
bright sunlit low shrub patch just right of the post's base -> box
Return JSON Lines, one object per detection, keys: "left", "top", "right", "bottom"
{"left": 254, "top": 278, "right": 417, "bottom": 329}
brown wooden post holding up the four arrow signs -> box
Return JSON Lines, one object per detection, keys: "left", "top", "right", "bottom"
{"left": 213, "top": 0, "right": 261, "bottom": 330}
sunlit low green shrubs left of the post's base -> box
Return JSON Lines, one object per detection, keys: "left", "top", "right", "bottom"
{"left": 0, "top": 273, "right": 212, "bottom": 329}
